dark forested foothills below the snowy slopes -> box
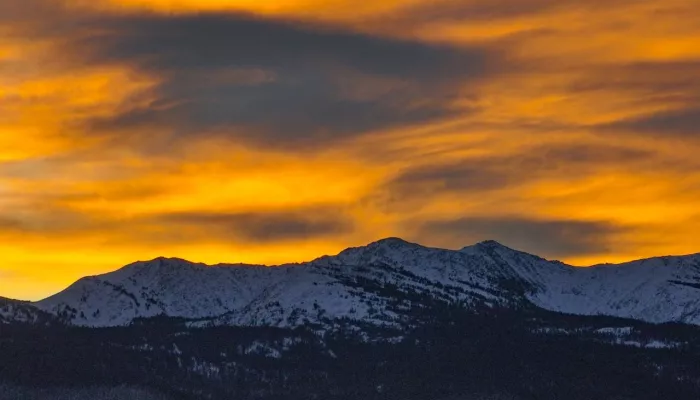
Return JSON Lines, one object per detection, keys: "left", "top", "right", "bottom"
{"left": 0, "top": 304, "right": 700, "bottom": 400}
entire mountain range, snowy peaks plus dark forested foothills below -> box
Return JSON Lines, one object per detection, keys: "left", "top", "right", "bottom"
{"left": 0, "top": 238, "right": 700, "bottom": 400}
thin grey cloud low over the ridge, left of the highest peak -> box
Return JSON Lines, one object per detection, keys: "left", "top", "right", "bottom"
{"left": 154, "top": 210, "right": 352, "bottom": 243}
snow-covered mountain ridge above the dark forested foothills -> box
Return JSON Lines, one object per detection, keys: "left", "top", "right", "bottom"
{"left": 34, "top": 238, "right": 700, "bottom": 327}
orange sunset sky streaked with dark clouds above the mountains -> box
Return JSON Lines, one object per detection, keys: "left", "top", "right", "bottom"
{"left": 0, "top": 0, "right": 700, "bottom": 300}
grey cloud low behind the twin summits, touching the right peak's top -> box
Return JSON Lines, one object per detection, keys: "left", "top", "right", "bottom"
{"left": 418, "top": 217, "right": 626, "bottom": 258}
